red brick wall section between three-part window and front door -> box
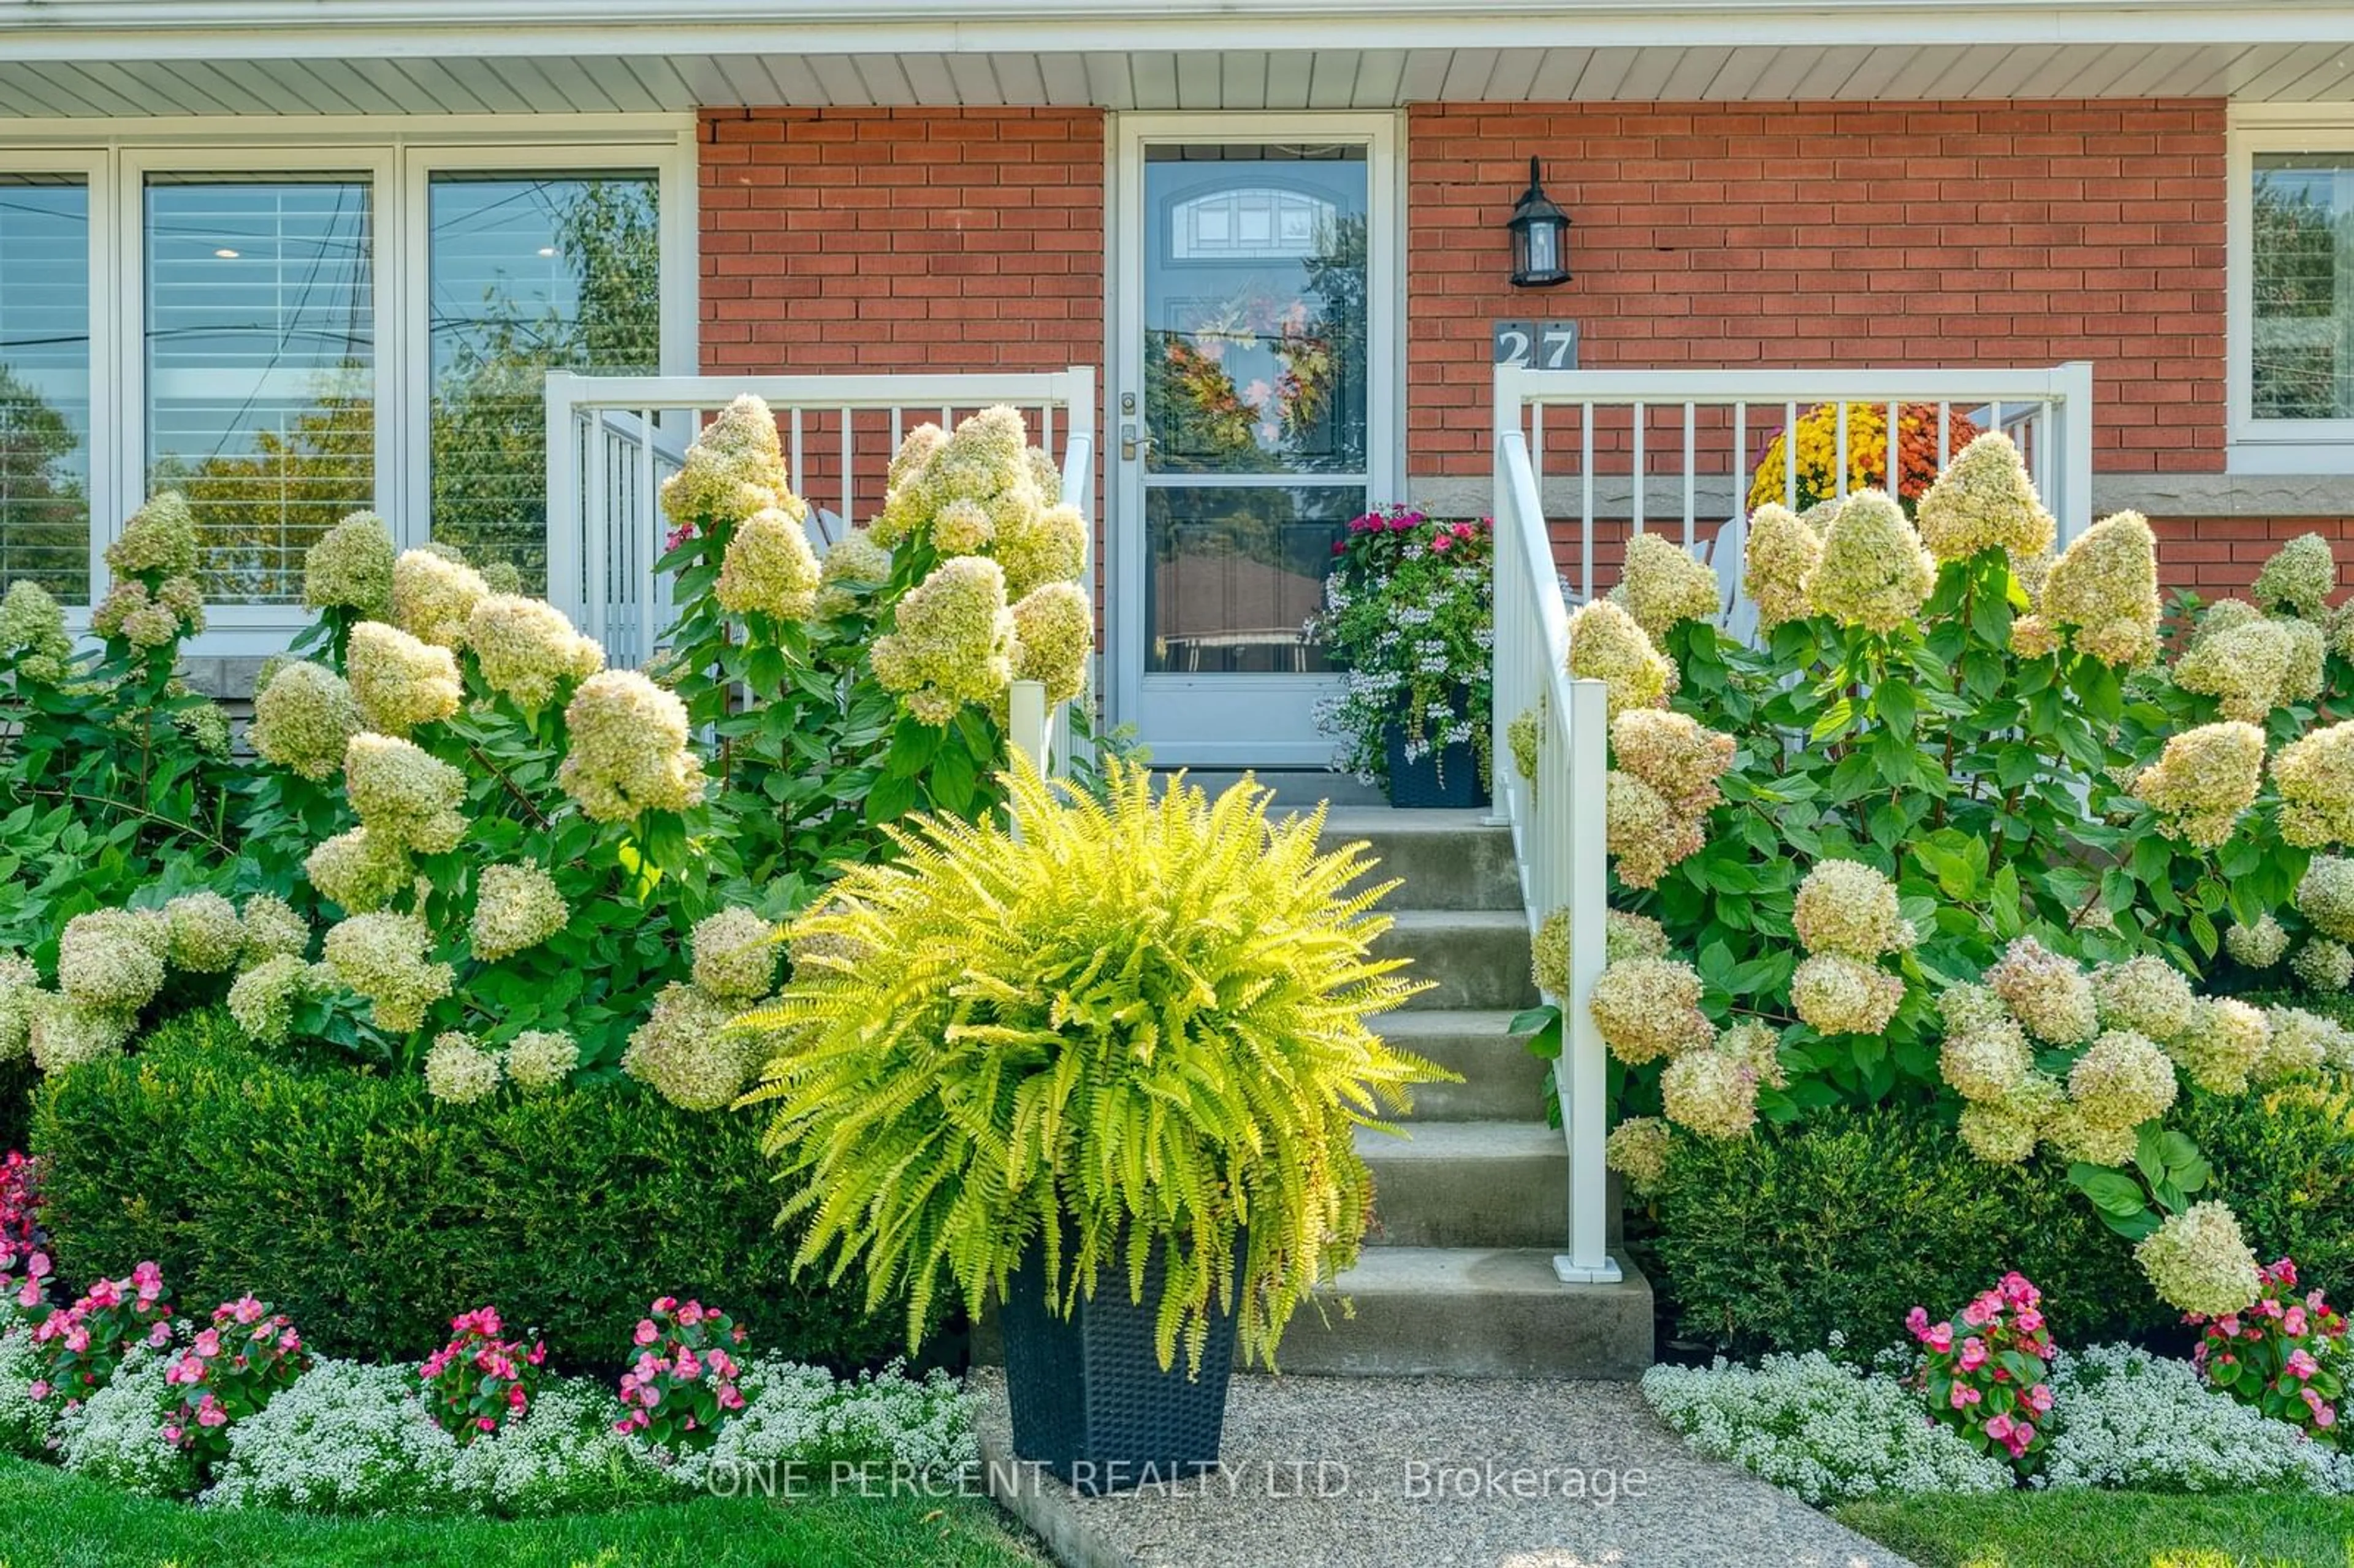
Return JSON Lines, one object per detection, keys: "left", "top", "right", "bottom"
{"left": 701, "top": 108, "right": 1104, "bottom": 375}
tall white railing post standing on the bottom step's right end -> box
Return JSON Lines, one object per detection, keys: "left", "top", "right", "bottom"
{"left": 1553, "top": 680, "right": 1620, "bottom": 1283}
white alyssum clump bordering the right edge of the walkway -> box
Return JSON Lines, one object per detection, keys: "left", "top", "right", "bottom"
{"left": 1643, "top": 1352, "right": 2013, "bottom": 1504}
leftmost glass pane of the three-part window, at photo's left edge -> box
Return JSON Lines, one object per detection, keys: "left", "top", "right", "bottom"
{"left": 0, "top": 174, "right": 90, "bottom": 605}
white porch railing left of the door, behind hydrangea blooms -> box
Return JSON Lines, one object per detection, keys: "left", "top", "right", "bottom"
{"left": 546, "top": 365, "right": 1095, "bottom": 772}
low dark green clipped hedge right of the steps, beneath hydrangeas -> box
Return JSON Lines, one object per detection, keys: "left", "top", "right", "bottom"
{"left": 1650, "top": 1081, "right": 2354, "bottom": 1353}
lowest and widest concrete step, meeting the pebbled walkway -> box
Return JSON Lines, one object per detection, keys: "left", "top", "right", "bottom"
{"left": 1276, "top": 1241, "right": 1653, "bottom": 1380}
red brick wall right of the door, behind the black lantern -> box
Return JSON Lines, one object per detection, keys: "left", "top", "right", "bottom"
{"left": 1405, "top": 101, "right": 2225, "bottom": 473}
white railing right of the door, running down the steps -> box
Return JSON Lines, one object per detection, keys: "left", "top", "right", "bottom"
{"left": 1493, "top": 362, "right": 2093, "bottom": 1281}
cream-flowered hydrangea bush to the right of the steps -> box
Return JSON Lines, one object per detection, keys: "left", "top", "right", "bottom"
{"left": 1537, "top": 433, "right": 2354, "bottom": 1311}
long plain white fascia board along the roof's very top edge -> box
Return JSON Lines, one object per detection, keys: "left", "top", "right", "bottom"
{"left": 13, "top": 0, "right": 2354, "bottom": 61}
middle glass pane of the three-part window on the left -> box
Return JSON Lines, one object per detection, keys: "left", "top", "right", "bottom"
{"left": 143, "top": 174, "right": 376, "bottom": 605}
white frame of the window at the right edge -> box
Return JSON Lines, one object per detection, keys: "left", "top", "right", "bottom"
{"left": 2225, "top": 104, "right": 2354, "bottom": 473}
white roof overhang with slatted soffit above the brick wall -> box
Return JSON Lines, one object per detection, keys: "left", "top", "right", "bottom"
{"left": 13, "top": 0, "right": 2354, "bottom": 118}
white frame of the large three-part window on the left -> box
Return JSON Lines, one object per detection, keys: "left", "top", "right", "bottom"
{"left": 0, "top": 115, "right": 701, "bottom": 657}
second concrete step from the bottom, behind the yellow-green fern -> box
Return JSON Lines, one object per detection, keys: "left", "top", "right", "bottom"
{"left": 1356, "top": 1121, "right": 1570, "bottom": 1248}
